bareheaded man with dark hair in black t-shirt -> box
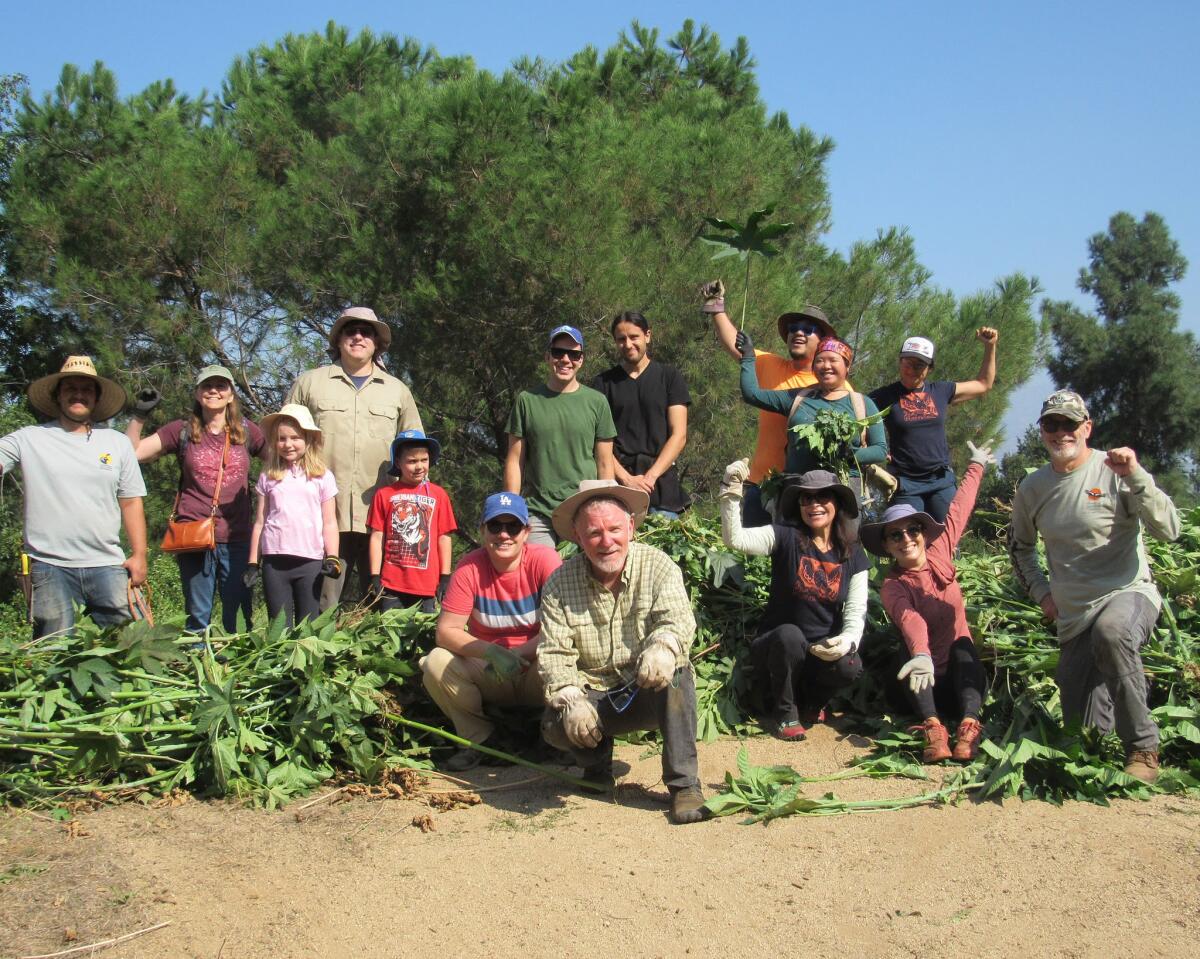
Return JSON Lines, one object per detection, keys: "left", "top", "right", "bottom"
{"left": 592, "top": 311, "right": 691, "bottom": 519}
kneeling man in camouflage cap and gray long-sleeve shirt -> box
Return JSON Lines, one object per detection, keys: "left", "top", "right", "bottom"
{"left": 1008, "top": 390, "right": 1180, "bottom": 783}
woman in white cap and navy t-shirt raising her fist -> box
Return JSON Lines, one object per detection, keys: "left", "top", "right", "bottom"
{"left": 871, "top": 326, "right": 1000, "bottom": 522}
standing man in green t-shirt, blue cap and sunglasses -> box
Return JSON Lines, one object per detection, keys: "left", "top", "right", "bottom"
{"left": 504, "top": 326, "right": 617, "bottom": 546}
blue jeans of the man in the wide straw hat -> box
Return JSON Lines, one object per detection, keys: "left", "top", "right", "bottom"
{"left": 29, "top": 559, "right": 133, "bottom": 640}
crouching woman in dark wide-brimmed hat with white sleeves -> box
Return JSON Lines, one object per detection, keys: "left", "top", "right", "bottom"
{"left": 721, "top": 460, "right": 870, "bottom": 742}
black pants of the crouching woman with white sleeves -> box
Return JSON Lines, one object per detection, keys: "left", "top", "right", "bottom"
{"left": 750, "top": 623, "right": 863, "bottom": 723}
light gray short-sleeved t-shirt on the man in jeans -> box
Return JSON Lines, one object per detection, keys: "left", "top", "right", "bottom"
{"left": 0, "top": 420, "right": 146, "bottom": 567}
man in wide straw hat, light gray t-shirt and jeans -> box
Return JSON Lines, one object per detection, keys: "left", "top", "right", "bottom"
{"left": 0, "top": 356, "right": 146, "bottom": 639}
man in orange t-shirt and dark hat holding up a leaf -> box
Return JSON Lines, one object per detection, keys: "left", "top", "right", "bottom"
{"left": 701, "top": 280, "right": 838, "bottom": 526}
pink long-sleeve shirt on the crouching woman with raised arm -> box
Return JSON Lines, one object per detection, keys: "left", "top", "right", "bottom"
{"left": 880, "top": 463, "right": 983, "bottom": 673}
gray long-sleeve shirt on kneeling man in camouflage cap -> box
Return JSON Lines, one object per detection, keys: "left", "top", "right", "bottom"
{"left": 1008, "top": 450, "right": 1180, "bottom": 642}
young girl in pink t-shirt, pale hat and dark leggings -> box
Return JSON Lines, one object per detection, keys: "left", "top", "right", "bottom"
{"left": 245, "top": 403, "right": 342, "bottom": 627}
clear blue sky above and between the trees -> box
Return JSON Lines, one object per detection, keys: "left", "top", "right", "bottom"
{"left": 0, "top": 0, "right": 1200, "bottom": 451}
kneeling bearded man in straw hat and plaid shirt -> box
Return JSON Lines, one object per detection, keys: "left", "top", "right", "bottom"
{"left": 538, "top": 480, "right": 704, "bottom": 822}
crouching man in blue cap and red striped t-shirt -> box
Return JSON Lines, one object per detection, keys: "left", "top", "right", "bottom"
{"left": 421, "top": 493, "right": 563, "bottom": 772}
